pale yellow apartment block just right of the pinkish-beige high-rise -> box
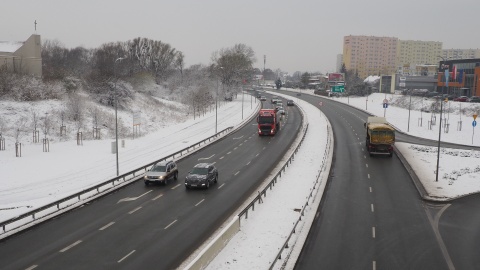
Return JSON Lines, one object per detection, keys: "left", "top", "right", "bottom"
{"left": 396, "top": 40, "right": 442, "bottom": 75}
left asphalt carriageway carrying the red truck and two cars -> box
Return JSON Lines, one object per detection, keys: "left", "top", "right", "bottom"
{"left": 0, "top": 93, "right": 302, "bottom": 270}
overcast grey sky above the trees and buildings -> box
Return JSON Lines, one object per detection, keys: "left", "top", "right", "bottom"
{"left": 0, "top": 0, "right": 480, "bottom": 74}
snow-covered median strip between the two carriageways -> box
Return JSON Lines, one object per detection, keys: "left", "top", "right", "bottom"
{"left": 197, "top": 92, "right": 333, "bottom": 269}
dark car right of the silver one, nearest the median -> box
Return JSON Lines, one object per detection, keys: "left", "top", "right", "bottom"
{"left": 185, "top": 163, "right": 218, "bottom": 189}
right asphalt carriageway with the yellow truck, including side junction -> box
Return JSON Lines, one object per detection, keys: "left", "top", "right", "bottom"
{"left": 276, "top": 90, "right": 480, "bottom": 269}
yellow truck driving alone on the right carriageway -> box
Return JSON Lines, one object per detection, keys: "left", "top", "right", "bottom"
{"left": 364, "top": 116, "right": 395, "bottom": 157}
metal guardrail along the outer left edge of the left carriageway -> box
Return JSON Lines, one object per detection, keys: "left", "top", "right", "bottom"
{"left": 0, "top": 127, "right": 234, "bottom": 236}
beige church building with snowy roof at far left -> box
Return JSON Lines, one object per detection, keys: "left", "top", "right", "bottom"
{"left": 0, "top": 35, "right": 42, "bottom": 77}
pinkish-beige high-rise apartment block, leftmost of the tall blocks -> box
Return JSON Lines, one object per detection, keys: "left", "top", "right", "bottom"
{"left": 343, "top": 35, "right": 398, "bottom": 78}
